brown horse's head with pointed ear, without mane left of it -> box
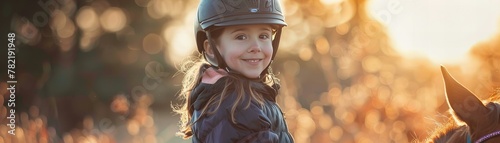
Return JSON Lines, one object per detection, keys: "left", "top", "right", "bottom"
{"left": 441, "top": 66, "right": 500, "bottom": 142}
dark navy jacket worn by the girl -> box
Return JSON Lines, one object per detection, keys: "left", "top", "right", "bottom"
{"left": 190, "top": 76, "right": 293, "bottom": 143}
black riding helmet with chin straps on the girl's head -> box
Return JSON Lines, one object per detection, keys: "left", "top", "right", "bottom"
{"left": 194, "top": 0, "right": 286, "bottom": 75}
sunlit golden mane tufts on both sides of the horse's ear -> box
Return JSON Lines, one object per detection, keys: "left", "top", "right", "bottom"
{"left": 425, "top": 88, "right": 500, "bottom": 143}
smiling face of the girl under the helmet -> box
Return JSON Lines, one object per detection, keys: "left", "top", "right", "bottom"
{"left": 205, "top": 25, "right": 273, "bottom": 78}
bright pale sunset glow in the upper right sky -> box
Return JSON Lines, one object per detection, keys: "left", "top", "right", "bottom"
{"left": 368, "top": 0, "right": 500, "bottom": 64}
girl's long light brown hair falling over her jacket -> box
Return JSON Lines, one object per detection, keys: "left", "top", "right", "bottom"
{"left": 173, "top": 29, "right": 279, "bottom": 139}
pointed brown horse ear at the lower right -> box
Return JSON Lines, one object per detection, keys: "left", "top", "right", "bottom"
{"left": 441, "top": 66, "right": 488, "bottom": 124}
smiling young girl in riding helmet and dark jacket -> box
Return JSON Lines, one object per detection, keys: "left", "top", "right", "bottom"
{"left": 176, "top": 0, "right": 293, "bottom": 143}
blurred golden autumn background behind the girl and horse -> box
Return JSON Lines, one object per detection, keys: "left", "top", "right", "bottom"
{"left": 0, "top": 0, "right": 500, "bottom": 143}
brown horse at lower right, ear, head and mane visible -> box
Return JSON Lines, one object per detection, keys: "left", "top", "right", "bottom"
{"left": 426, "top": 66, "right": 500, "bottom": 143}
